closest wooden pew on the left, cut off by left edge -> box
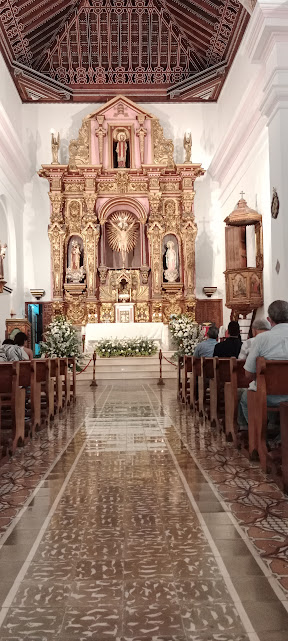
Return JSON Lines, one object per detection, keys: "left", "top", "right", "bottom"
{"left": 0, "top": 361, "right": 26, "bottom": 454}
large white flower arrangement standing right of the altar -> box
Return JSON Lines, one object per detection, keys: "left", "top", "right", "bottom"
{"left": 169, "top": 314, "right": 205, "bottom": 358}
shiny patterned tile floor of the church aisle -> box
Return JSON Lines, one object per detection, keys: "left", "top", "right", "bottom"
{"left": 0, "top": 381, "right": 288, "bottom": 641}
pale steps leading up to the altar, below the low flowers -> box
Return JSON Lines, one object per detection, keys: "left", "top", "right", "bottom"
{"left": 77, "top": 352, "right": 177, "bottom": 382}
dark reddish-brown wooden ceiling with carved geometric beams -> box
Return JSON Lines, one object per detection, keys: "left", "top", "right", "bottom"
{"left": 0, "top": 0, "right": 253, "bottom": 102}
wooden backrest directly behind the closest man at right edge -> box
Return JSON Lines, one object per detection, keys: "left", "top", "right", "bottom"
{"left": 256, "top": 357, "right": 288, "bottom": 396}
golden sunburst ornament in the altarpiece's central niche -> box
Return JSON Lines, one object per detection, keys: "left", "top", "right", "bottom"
{"left": 107, "top": 211, "right": 139, "bottom": 267}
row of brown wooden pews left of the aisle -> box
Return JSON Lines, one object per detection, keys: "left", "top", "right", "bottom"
{"left": 0, "top": 358, "right": 76, "bottom": 463}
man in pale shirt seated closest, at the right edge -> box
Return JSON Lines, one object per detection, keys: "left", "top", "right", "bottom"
{"left": 238, "top": 300, "right": 288, "bottom": 427}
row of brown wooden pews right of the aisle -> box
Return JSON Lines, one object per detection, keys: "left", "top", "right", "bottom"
{"left": 178, "top": 356, "right": 288, "bottom": 492}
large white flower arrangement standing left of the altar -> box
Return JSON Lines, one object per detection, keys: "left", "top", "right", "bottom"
{"left": 40, "top": 316, "right": 82, "bottom": 369}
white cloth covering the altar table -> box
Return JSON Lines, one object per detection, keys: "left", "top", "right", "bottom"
{"left": 85, "top": 323, "right": 169, "bottom": 352}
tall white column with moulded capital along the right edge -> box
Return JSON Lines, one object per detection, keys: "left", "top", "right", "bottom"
{"left": 250, "top": 0, "right": 288, "bottom": 300}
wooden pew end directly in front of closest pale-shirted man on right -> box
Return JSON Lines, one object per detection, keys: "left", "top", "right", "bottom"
{"left": 224, "top": 357, "right": 249, "bottom": 447}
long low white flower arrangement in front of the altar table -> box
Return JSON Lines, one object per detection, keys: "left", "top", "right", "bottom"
{"left": 95, "top": 338, "right": 157, "bottom": 358}
